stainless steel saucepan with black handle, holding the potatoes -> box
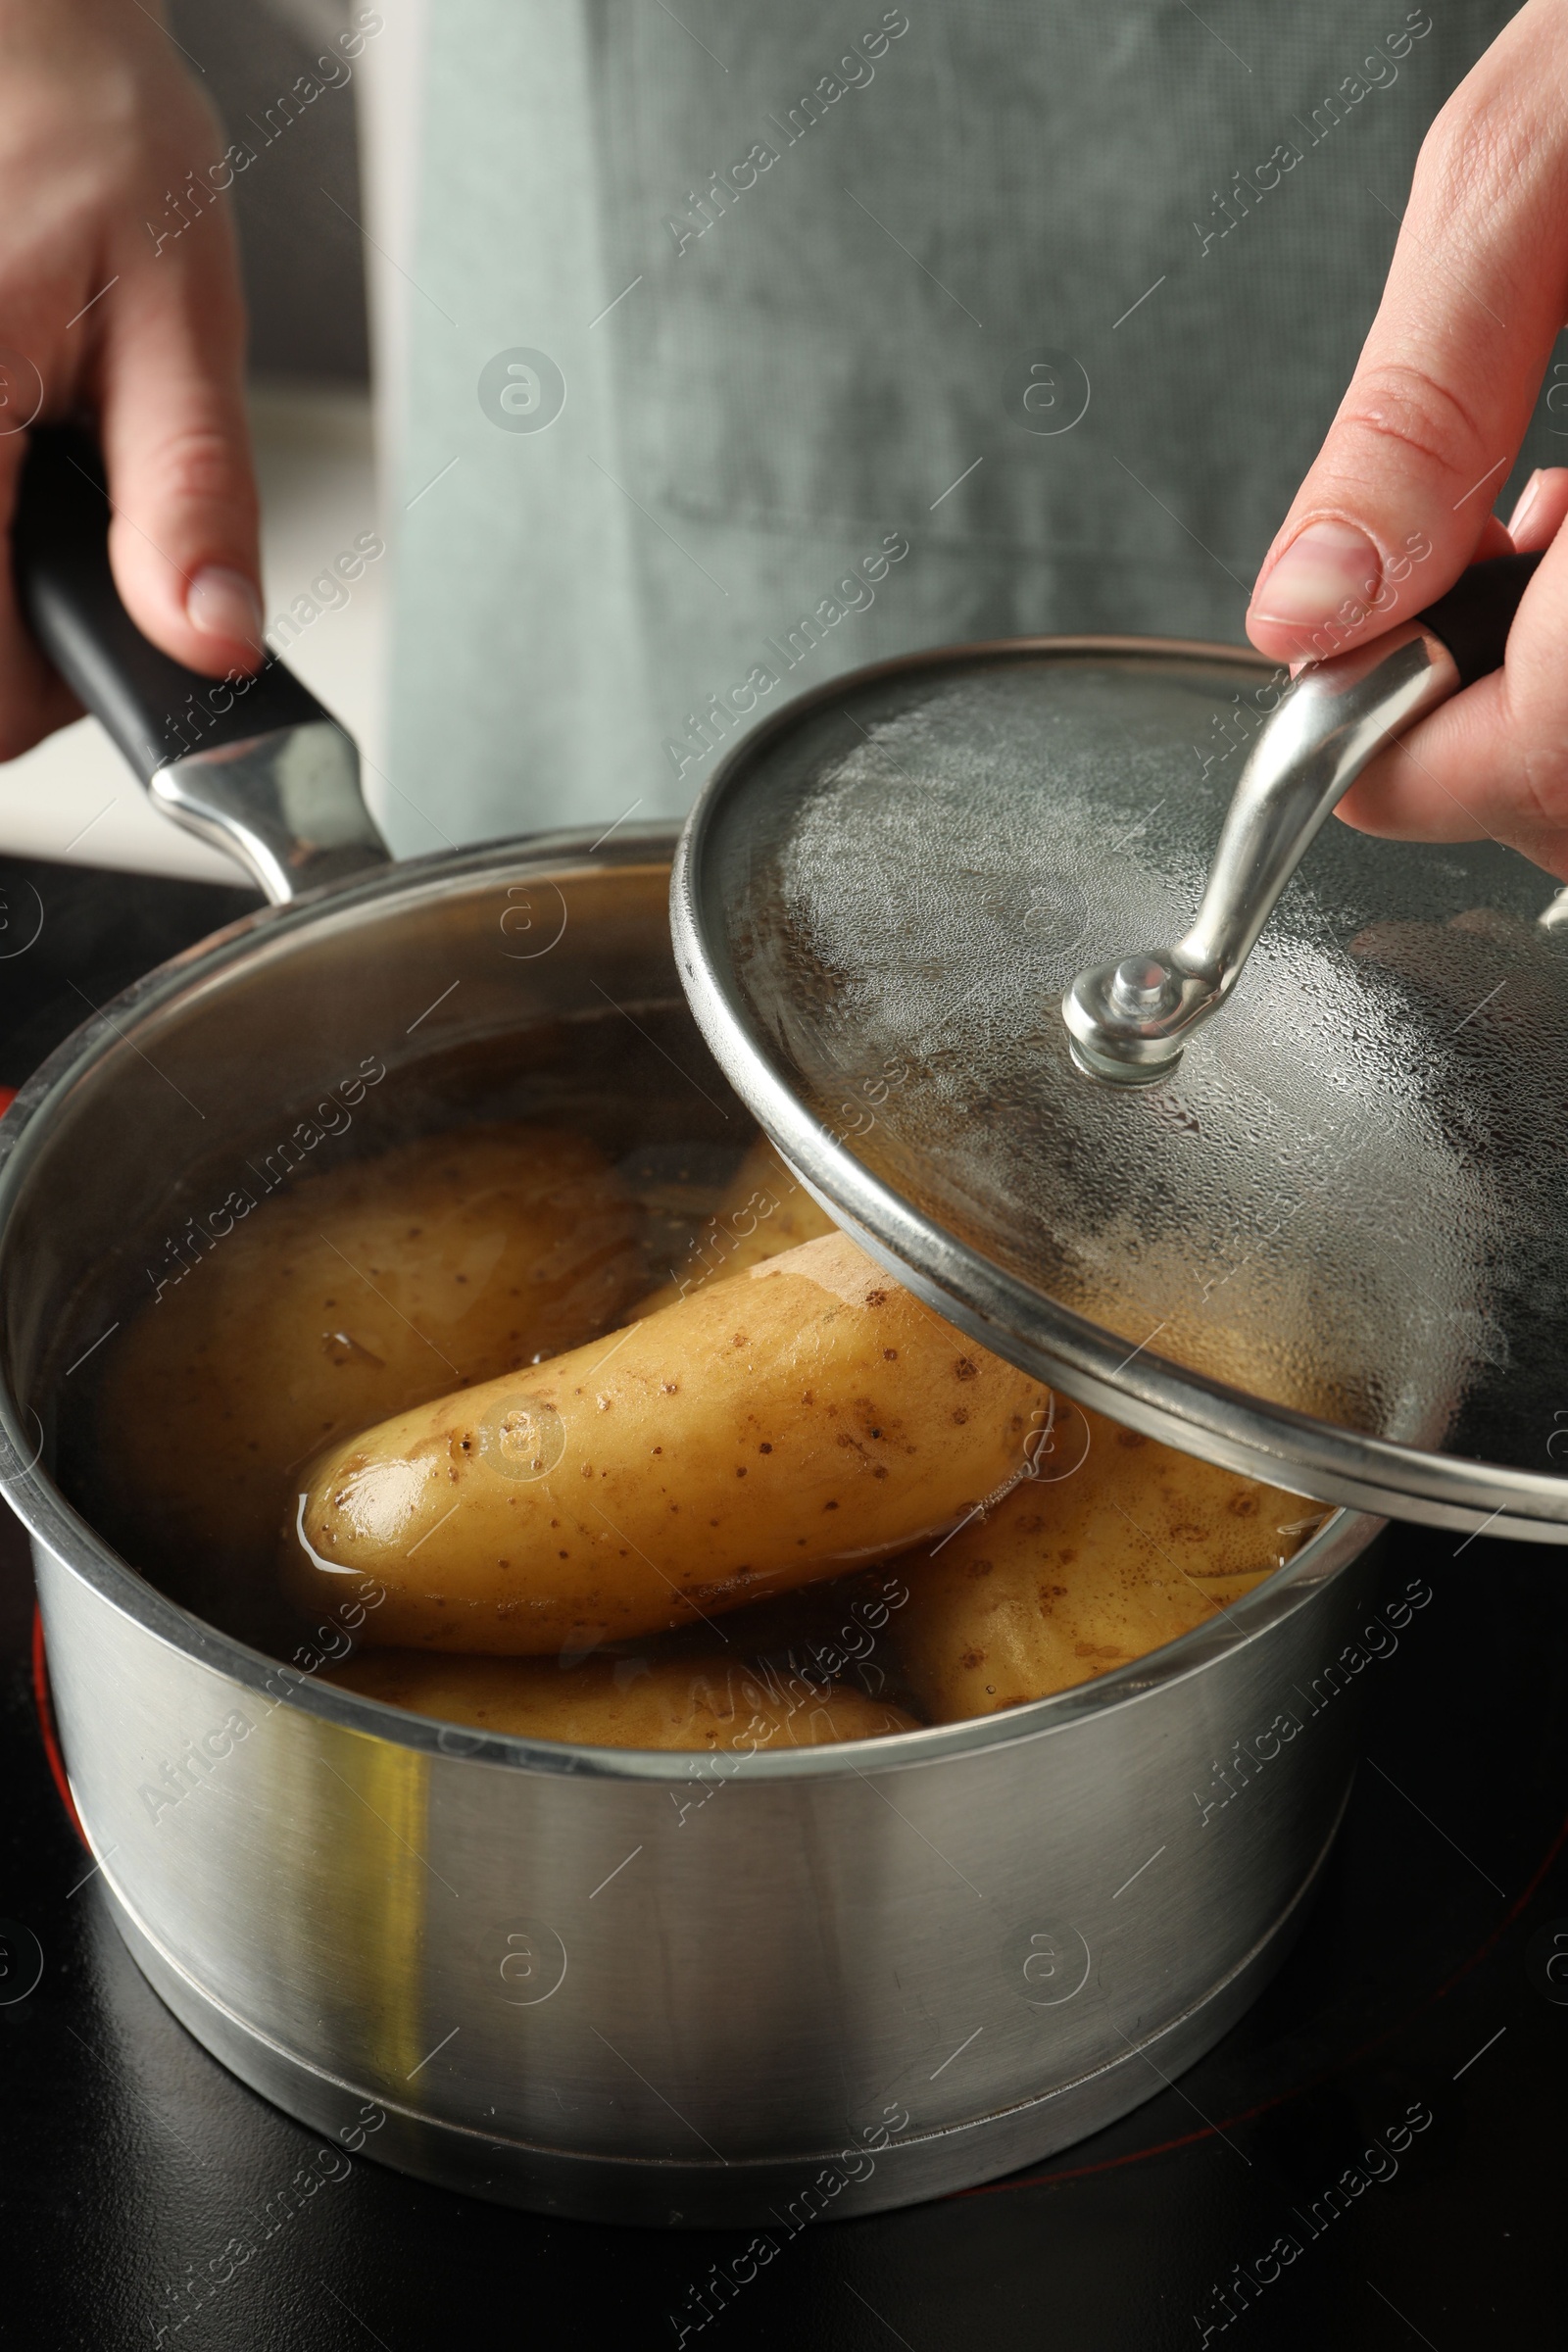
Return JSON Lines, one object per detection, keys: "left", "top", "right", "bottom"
{"left": 0, "top": 432, "right": 1417, "bottom": 2211}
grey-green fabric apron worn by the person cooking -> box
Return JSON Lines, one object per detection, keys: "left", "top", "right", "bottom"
{"left": 390, "top": 0, "right": 1563, "bottom": 849}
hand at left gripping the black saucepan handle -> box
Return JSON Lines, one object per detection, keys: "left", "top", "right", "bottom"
{"left": 0, "top": 0, "right": 264, "bottom": 760}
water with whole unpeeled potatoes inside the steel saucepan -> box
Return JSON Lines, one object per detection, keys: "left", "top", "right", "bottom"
{"left": 59, "top": 1011, "right": 1321, "bottom": 1750}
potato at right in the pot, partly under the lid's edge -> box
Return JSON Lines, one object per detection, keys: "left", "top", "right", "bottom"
{"left": 896, "top": 1399, "right": 1324, "bottom": 1724}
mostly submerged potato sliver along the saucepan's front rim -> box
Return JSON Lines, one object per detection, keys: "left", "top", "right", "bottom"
{"left": 331, "top": 1648, "right": 917, "bottom": 1754}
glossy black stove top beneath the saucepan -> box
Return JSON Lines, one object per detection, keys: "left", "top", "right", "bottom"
{"left": 0, "top": 860, "right": 1568, "bottom": 2352}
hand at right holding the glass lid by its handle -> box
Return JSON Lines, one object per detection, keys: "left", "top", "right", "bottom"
{"left": 1246, "top": 0, "right": 1568, "bottom": 880}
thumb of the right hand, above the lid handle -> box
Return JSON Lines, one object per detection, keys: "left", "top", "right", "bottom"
{"left": 1246, "top": 0, "right": 1568, "bottom": 661}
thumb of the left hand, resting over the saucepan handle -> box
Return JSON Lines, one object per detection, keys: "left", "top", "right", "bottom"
{"left": 101, "top": 254, "right": 266, "bottom": 675}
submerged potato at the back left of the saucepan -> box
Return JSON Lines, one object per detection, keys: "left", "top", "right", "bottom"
{"left": 99, "top": 1127, "right": 639, "bottom": 1574}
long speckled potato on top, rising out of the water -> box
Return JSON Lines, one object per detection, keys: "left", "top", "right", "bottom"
{"left": 284, "top": 1233, "right": 1046, "bottom": 1653}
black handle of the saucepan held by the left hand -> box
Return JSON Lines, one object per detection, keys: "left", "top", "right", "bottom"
{"left": 12, "top": 425, "right": 331, "bottom": 783}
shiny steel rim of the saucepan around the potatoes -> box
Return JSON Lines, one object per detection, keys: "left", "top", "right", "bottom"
{"left": 0, "top": 821, "right": 1387, "bottom": 1786}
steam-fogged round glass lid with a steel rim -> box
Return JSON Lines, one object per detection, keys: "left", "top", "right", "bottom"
{"left": 672, "top": 640, "right": 1568, "bottom": 1541}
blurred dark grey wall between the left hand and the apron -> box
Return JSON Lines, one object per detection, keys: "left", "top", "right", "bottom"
{"left": 170, "top": 0, "right": 369, "bottom": 383}
